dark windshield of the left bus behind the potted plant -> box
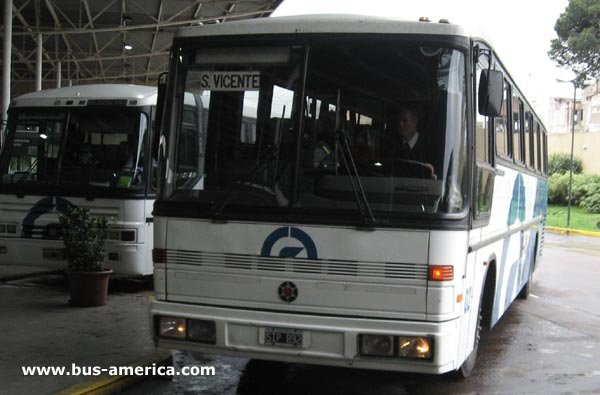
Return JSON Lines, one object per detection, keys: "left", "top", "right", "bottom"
{"left": 0, "top": 107, "right": 148, "bottom": 191}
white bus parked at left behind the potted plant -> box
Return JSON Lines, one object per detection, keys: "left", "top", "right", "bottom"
{"left": 0, "top": 84, "right": 162, "bottom": 275}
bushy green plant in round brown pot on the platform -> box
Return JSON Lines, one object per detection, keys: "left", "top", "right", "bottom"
{"left": 59, "top": 207, "right": 112, "bottom": 307}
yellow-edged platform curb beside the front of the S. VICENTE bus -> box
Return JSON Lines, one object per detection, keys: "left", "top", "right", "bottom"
{"left": 53, "top": 351, "right": 173, "bottom": 395}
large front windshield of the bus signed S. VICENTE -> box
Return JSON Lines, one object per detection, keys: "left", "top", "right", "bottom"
{"left": 165, "top": 38, "right": 468, "bottom": 224}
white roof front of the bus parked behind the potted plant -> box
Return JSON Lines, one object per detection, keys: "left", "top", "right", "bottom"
{"left": 11, "top": 84, "right": 157, "bottom": 107}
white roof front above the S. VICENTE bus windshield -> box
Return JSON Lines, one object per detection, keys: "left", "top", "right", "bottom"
{"left": 176, "top": 14, "right": 470, "bottom": 37}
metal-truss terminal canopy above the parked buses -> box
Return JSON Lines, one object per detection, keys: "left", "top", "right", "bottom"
{"left": 0, "top": 0, "right": 282, "bottom": 97}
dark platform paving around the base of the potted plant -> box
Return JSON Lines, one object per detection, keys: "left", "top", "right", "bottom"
{"left": 0, "top": 272, "right": 155, "bottom": 395}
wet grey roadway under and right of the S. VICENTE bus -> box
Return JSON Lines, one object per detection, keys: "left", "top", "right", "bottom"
{"left": 127, "top": 234, "right": 600, "bottom": 395}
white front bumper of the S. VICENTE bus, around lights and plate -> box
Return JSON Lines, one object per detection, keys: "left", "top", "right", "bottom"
{"left": 151, "top": 301, "right": 459, "bottom": 374}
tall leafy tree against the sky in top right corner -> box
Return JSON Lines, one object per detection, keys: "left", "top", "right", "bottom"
{"left": 548, "top": 0, "right": 600, "bottom": 85}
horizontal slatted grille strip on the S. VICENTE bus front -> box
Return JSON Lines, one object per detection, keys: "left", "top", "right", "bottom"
{"left": 167, "top": 250, "right": 427, "bottom": 280}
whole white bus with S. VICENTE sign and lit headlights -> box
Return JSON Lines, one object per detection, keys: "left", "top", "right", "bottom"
{"left": 151, "top": 16, "right": 547, "bottom": 376}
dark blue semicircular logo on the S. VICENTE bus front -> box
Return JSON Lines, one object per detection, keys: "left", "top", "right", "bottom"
{"left": 260, "top": 226, "right": 318, "bottom": 259}
